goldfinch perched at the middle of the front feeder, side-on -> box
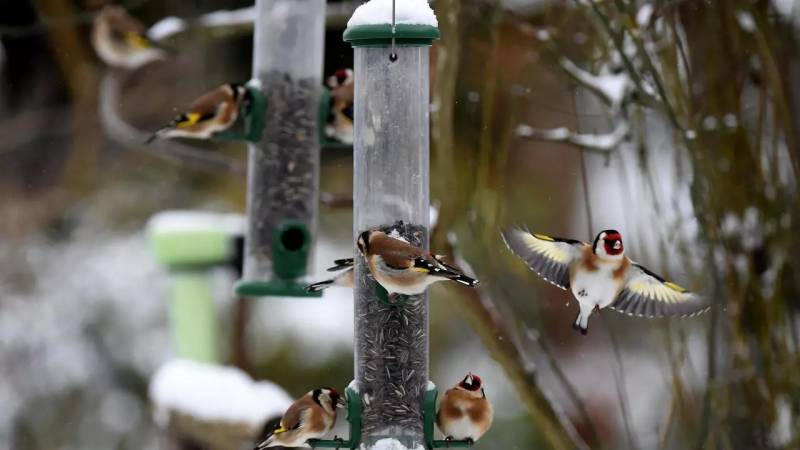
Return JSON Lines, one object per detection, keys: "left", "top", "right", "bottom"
{"left": 358, "top": 230, "right": 478, "bottom": 295}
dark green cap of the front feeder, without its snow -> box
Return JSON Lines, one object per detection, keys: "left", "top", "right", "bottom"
{"left": 344, "top": 23, "right": 440, "bottom": 47}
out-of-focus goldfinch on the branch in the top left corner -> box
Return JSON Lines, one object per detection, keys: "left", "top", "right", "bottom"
{"left": 91, "top": 5, "right": 168, "bottom": 70}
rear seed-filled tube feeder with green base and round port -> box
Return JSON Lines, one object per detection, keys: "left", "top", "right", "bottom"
{"left": 236, "top": 0, "right": 325, "bottom": 297}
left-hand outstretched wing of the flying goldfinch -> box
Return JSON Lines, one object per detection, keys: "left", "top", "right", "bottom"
{"left": 503, "top": 228, "right": 589, "bottom": 289}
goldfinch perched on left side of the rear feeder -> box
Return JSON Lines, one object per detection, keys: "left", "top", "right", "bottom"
{"left": 147, "top": 83, "right": 249, "bottom": 143}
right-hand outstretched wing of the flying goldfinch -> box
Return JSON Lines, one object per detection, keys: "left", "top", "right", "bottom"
{"left": 610, "top": 263, "right": 709, "bottom": 317}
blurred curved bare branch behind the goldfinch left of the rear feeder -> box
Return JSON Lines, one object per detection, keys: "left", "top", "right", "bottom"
{"left": 99, "top": 72, "right": 245, "bottom": 175}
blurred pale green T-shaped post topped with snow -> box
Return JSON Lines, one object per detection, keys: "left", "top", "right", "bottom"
{"left": 147, "top": 211, "right": 244, "bottom": 363}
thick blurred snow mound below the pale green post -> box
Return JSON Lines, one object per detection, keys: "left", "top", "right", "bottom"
{"left": 150, "top": 359, "right": 292, "bottom": 428}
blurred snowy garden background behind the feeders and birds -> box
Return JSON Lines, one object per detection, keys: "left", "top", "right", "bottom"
{"left": 0, "top": 0, "right": 800, "bottom": 450}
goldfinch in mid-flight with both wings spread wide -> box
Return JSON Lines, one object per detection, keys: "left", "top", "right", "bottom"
{"left": 503, "top": 228, "right": 708, "bottom": 334}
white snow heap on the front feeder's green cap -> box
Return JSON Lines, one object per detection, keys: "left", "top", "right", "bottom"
{"left": 347, "top": 0, "right": 439, "bottom": 27}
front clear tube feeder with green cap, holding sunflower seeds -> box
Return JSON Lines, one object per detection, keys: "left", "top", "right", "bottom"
{"left": 344, "top": 6, "right": 439, "bottom": 448}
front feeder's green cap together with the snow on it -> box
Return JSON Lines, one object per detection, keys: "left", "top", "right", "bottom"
{"left": 344, "top": 0, "right": 439, "bottom": 47}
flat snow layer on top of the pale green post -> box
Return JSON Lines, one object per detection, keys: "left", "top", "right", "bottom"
{"left": 147, "top": 211, "right": 245, "bottom": 234}
